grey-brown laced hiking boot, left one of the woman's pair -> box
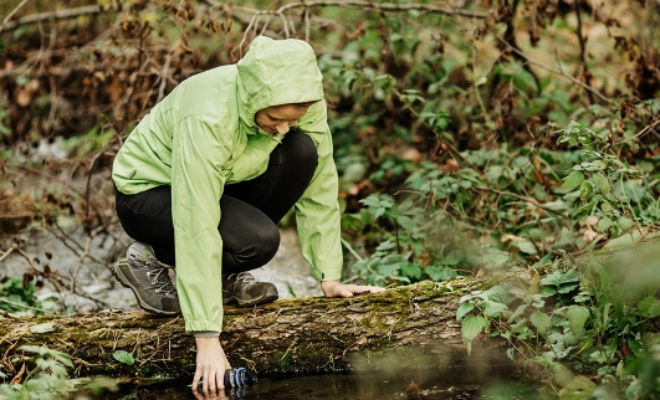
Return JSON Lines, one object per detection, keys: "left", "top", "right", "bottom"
{"left": 112, "top": 242, "right": 180, "bottom": 315}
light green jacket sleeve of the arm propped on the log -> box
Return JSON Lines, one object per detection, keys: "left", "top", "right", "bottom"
{"left": 295, "top": 101, "right": 343, "bottom": 281}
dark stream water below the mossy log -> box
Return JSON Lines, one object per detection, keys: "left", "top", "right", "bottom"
{"left": 105, "top": 348, "right": 537, "bottom": 400}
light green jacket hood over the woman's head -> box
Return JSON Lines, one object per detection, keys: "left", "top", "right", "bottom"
{"left": 236, "top": 36, "right": 323, "bottom": 132}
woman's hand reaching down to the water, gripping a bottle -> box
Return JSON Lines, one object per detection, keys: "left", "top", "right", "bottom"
{"left": 192, "top": 338, "right": 231, "bottom": 398}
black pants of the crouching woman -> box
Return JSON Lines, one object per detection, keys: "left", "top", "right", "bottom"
{"left": 115, "top": 128, "right": 318, "bottom": 273}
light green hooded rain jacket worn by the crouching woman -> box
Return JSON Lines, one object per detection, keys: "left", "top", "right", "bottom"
{"left": 112, "top": 36, "right": 342, "bottom": 332}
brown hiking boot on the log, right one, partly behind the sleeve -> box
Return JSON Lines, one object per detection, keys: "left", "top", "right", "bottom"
{"left": 222, "top": 272, "right": 278, "bottom": 307}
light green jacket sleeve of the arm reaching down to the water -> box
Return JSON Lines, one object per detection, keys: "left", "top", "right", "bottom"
{"left": 172, "top": 116, "right": 231, "bottom": 332}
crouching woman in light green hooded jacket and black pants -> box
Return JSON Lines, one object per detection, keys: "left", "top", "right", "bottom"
{"left": 112, "top": 36, "right": 382, "bottom": 394}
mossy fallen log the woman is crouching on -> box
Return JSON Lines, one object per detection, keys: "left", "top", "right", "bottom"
{"left": 0, "top": 279, "right": 500, "bottom": 377}
